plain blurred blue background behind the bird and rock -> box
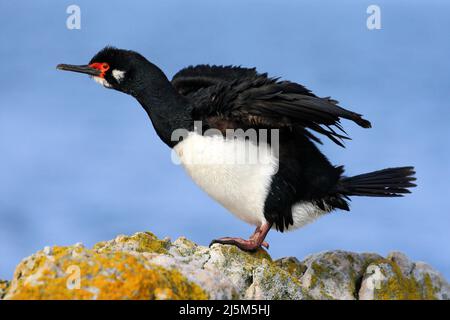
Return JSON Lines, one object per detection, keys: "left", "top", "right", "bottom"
{"left": 0, "top": 0, "right": 450, "bottom": 279}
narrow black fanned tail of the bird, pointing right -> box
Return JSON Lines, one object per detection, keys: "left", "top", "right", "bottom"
{"left": 339, "top": 167, "right": 416, "bottom": 197}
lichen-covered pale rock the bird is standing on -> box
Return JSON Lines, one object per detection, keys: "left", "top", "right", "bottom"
{"left": 0, "top": 232, "right": 450, "bottom": 299}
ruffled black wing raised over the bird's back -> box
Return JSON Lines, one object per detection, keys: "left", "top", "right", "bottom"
{"left": 172, "top": 65, "right": 371, "bottom": 146}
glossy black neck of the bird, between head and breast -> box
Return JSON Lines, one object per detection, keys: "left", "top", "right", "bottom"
{"left": 132, "top": 65, "right": 193, "bottom": 147}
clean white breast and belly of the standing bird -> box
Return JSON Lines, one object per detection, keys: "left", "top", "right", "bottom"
{"left": 174, "top": 132, "right": 278, "bottom": 226}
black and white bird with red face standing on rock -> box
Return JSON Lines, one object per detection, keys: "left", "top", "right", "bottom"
{"left": 57, "top": 47, "right": 415, "bottom": 251}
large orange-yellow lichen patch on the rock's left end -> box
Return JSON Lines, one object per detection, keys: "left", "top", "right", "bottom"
{"left": 8, "top": 247, "right": 208, "bottom": 300}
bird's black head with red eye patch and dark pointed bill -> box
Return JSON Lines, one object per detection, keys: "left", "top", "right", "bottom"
{"left": 56, "top": 47, "right": 153, "bottom": 94}
